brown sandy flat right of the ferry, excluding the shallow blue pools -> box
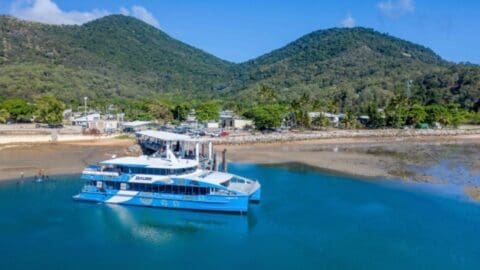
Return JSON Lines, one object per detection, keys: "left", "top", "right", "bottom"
{"left": 216, "top": 135, "right": 480, "bottom": 182}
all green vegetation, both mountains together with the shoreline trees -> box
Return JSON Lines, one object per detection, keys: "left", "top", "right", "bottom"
{"left": 0, "top": 15, "right": 480, "bottom": 128}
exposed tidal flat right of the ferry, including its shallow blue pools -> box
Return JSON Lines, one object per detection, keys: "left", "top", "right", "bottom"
{"left": 216, "top": 135, "right": 480, "bottom": 201}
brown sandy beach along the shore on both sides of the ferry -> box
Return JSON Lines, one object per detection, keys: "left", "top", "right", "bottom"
{"left": 0, "top": 130, "right": 480, "bottom": 198}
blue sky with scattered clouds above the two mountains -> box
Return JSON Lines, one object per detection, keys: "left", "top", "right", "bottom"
{"left": 0, "top": 0, "right": 480, "bottom": 64}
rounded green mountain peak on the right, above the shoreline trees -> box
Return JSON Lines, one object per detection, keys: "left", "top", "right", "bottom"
{"left": 232, "top": 27, "right": 472, "bottom": 108}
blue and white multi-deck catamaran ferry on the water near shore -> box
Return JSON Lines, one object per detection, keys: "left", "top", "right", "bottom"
{"left": 73, "top": 130, "right": 261, "bottom": 214}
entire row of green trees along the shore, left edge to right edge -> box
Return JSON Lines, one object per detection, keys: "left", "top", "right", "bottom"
{"left": 0, "top": 85, "right": 480, "bottom": 130}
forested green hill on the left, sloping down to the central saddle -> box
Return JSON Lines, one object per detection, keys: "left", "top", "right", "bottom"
{"left": 0, "top": 15, "right": 232, "bottom": 99}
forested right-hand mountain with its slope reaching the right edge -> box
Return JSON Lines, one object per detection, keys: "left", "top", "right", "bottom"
{"left": 231, "top": 28, "right": 480, "bottom": 112}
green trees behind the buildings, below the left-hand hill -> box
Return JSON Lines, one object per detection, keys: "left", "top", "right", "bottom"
{"left": 0, "top": 95, "right": 221, "bottom": 124}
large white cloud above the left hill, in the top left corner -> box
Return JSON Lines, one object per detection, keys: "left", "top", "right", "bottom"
{"left": 10, "top": 0, "right": 110, "bottom": 24}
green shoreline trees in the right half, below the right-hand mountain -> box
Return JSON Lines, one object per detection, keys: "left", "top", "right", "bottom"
{"left": 237, "top": 85, "right": 480, "bottom": 129}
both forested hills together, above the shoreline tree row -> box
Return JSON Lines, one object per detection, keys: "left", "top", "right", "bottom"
{"left": 0, "top": 15, "right": 480, "bottom": 109}
